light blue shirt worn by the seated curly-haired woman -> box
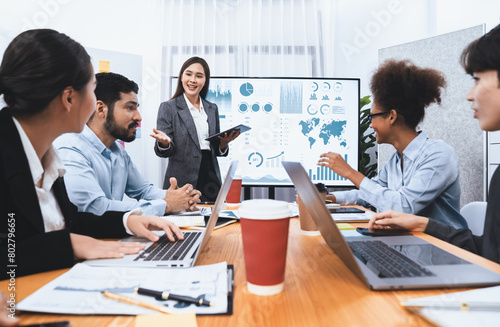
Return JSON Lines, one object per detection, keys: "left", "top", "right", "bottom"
{"left": 333, "top": 132, "right": 467, "bottom": 228}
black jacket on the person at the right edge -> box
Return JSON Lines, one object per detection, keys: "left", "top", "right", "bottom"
{"left": 425, "top": 168, "right": 500, "bottom": 263}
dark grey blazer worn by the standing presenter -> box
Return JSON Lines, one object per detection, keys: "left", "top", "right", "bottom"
{"left": 154, "top": 96, "right": 229, "bottom": 188}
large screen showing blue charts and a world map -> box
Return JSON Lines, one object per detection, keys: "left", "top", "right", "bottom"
{"left": 171, "top": 77, "right": 360, "bottom": 186}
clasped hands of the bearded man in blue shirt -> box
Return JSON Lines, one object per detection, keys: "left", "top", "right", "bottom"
{"left": 165, "top": 177, "right": 201, "bottom": 213}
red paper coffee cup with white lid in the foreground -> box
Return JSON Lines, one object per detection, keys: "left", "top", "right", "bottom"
{"left": 238, "top": 199, "right": 290, "bottom": 295}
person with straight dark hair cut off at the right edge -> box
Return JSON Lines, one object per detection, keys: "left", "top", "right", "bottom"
{"left": 369, "top": 25, "right": 500, "bottom": 263}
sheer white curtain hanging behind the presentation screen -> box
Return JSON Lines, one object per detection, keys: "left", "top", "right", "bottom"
{"left": 158, "top": 0, "right": 335, "bottom": 200}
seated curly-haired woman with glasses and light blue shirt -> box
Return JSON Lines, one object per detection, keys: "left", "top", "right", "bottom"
{"left": 318, "top": 60, "right": 467, "bottom": 228}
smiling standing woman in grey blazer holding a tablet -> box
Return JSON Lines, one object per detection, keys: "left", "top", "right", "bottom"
{"left": 151, "top": 57, "right": 239, "bottom": 202}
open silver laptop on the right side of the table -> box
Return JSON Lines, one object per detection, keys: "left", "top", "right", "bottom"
{"left": 282, "top": 161, "right": 500, "bottom": 290}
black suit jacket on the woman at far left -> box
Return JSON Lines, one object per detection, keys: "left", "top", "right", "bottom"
{"left": 0, "top": 108, "right": 127, "bottom": 279}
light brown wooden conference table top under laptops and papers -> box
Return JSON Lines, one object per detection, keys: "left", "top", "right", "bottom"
{"left": 0, "top": 209, "right": 500, "bottom": 327}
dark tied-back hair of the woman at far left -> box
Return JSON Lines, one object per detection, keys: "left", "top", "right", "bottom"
{"left": 0, "top": 29, "right": 92, "bottom": 117}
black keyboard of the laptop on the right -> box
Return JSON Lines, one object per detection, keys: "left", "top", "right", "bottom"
{"left": 347, "top": 241, "right": 435, "bottom": 278}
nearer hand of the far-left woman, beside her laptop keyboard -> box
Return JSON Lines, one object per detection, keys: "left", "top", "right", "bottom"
{"left": 69, "top": 234, "right": 145, "bottom": 259}
